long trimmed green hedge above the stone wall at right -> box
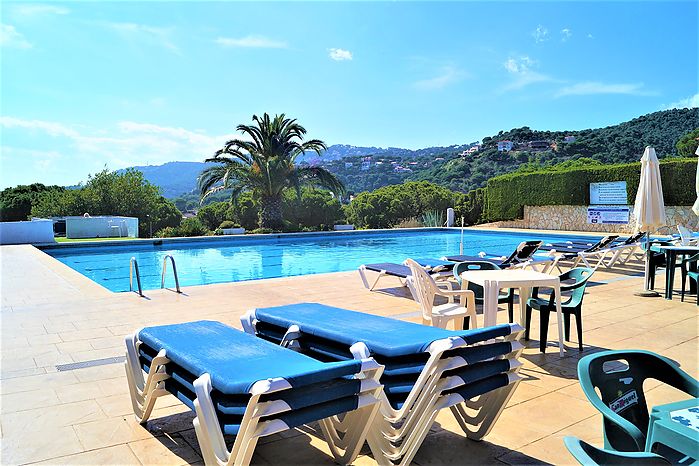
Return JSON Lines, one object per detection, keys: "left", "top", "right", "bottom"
{"left": 484, "top": 158, "right": 697, "bottom": 222}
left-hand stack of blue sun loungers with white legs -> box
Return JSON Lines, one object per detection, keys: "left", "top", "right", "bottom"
{"left": 126, "top": 321, "right": 383, "bottom": 466}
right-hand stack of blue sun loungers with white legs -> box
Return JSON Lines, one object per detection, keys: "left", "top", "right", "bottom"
{"left": 242, "top": 303, "right": 523, "bottom": 465}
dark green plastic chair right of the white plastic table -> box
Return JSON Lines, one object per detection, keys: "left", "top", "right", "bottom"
{"left": 524, "top": 267, "right": 594, "bottom": 353}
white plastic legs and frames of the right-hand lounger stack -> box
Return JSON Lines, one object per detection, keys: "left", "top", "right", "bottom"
{"left": 241, "top": 310, "right": 524, "bottom": 466}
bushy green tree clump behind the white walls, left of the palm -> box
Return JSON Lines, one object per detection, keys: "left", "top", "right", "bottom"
{"left": 32, "top": 168, "right": 182, "bottom": 237}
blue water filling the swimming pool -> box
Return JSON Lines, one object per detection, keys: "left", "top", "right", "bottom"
{"left": 44, "top": 229, "right": 600, "bottom": 291}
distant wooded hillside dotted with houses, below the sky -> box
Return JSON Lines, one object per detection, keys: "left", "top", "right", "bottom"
{"left": 119, "top": 108, "right": 699, "bottom": 202}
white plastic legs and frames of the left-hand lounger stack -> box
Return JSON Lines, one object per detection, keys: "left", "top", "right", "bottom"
{"left": 125, "top": 332, "right": 383, "bottom": 466}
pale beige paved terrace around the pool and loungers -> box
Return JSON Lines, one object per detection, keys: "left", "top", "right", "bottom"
{"left": 0, "top": 246, "right": 699, "bottom": 465}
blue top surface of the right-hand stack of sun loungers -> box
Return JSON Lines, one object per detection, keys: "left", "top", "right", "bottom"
{"left": 255, "top": 303, "right": 512, "bottom": 357}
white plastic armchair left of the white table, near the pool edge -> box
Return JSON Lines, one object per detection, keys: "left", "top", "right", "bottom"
{"left": 405, "top": 259, "right": 478, "bottom": 329}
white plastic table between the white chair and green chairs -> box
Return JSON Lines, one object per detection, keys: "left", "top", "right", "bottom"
{"left": 461, "top": 269, "right": 565, "bottom": 357}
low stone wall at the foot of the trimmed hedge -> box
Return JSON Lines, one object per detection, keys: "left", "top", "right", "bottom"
{"left": 496, "top": 205, "right": 699, "bottom": 233}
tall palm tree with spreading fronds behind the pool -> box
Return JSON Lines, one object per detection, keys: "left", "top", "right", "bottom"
{"left": 198, "top": 113, "right": 345, "bottom": 229}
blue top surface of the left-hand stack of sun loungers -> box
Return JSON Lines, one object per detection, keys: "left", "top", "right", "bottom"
{"left": 138, "top": 321, "right": 361, "bottom": 394}
